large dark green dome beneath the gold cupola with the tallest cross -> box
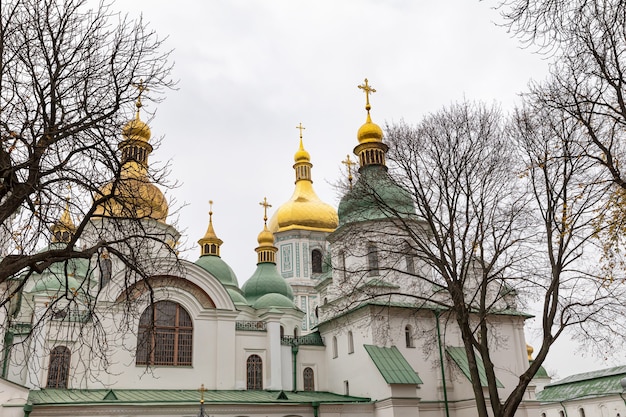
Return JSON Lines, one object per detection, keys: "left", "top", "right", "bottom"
{"left": 338, "top": 165, "right": 416, "bottom": 227}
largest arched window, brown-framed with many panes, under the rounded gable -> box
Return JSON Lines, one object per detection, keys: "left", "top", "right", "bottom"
{"left": 137, "top": 301, "right": 193, "bottom": 366}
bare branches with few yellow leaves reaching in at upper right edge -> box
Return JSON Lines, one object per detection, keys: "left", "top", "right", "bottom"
{"left": 500, "top": 0, "right": 626, "bottom": 272}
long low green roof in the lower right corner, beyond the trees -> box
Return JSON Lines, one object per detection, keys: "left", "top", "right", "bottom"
{"left": 537, "top": 366, "right": 626, "bottom": 402}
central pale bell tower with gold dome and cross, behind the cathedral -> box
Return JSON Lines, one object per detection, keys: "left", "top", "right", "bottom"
{"left": 269, "top": 123, "right": 339, "bottom": 334}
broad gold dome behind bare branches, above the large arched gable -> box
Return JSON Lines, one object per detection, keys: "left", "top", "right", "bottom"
{"left": 94, "top": 162, "right": 169, "bottom": 223}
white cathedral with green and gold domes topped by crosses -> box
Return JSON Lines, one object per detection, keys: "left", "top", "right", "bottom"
{"left": 0, "top": 80, "right": 541, "bottom": 417}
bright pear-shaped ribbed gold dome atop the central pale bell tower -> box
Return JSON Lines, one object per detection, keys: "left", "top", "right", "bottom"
{"left": 269, "top": 137, "right": 339, "bottom": 233}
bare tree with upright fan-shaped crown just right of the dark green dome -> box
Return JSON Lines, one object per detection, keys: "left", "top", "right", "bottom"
{"left": 387, "top": 102, "right": 531, "bottom": 416}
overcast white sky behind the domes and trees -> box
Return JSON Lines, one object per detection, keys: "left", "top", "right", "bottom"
{"left": 115, "top": 0, "right": 624, "bottom": 378}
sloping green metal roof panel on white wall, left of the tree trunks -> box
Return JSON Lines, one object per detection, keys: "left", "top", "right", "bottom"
{"left": 363, "top": 345, "right": 423, "bottom": 385}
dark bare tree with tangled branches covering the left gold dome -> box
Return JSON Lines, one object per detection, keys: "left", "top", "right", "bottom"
{"left": 0, "top": 0, "right": 178, "bottom": 380}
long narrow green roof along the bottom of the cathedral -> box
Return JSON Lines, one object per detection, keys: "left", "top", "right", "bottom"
{"left": 28, "top": 389, "right": 371, "bottom": 406}
